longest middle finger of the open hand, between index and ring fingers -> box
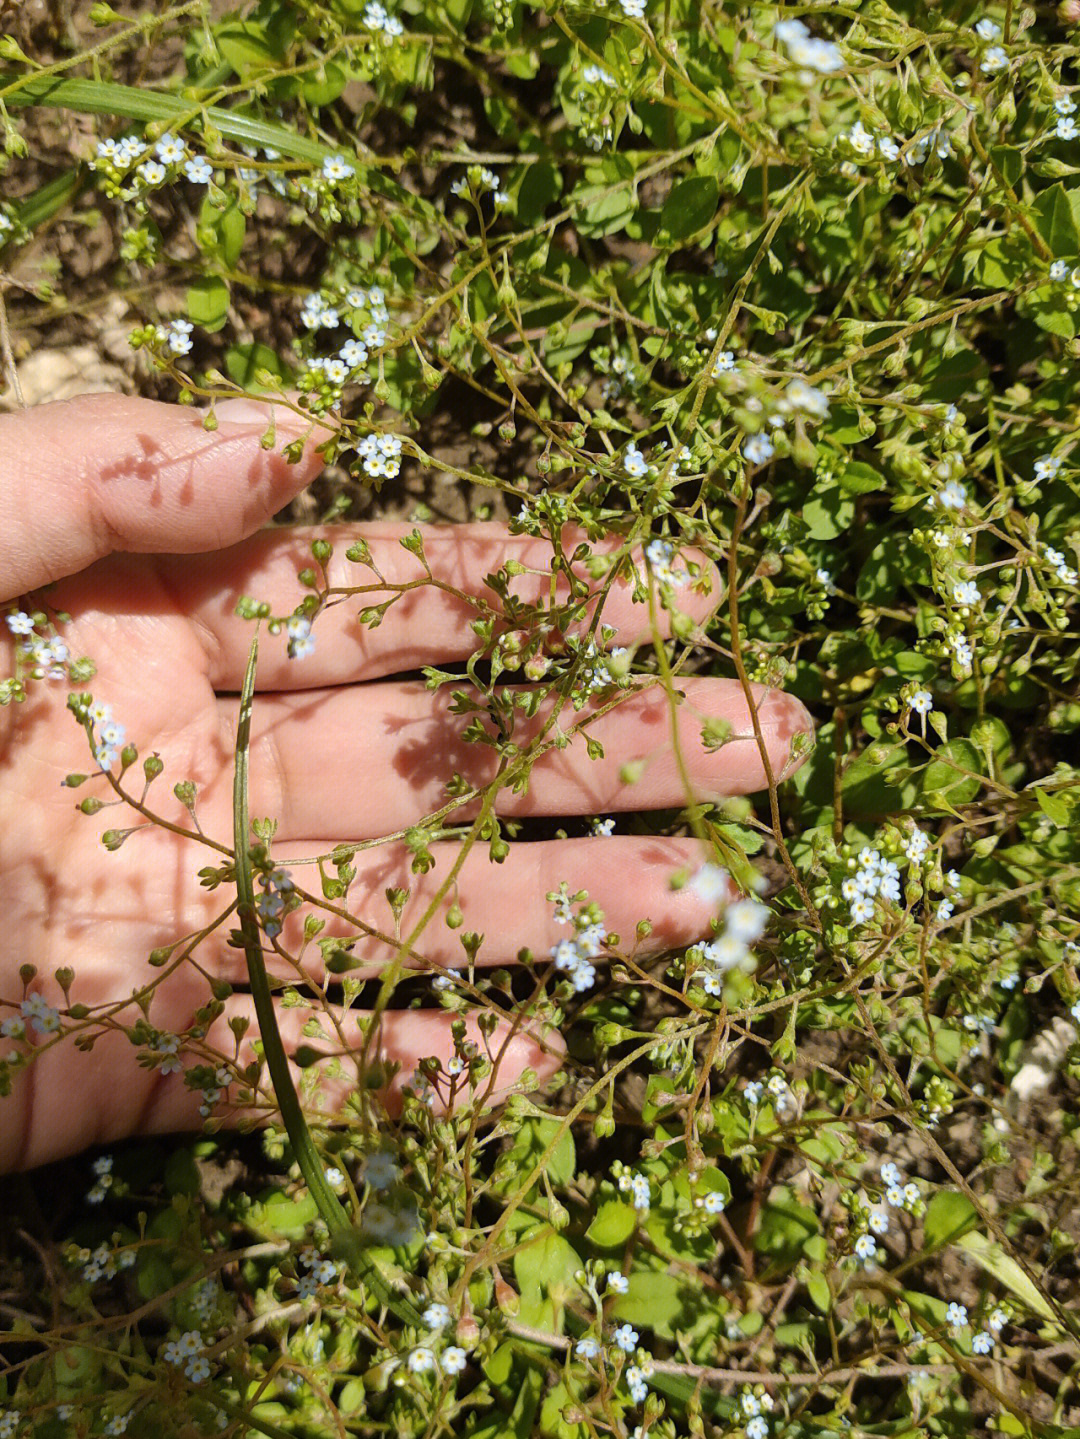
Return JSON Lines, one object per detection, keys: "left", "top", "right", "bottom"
{"left": 217, "top": 676, "right": 813, "bottom": 842}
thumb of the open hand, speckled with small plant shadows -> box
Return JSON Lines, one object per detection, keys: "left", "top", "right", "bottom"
{"left": 0, "top": 394, "right": 332, "bottom": 600}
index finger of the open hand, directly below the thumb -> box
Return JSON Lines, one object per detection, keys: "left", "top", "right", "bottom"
{"left": 152, "top": 521, "right": 720, "bottom": 692}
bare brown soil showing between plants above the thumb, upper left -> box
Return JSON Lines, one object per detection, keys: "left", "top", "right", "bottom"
{"left": 0, "top": 0, "right": 509, "bottom": 522}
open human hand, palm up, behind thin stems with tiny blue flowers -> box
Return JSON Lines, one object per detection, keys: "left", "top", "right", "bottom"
{"left": 0, "top": 394, "right": 811, "bottom": 1171}
